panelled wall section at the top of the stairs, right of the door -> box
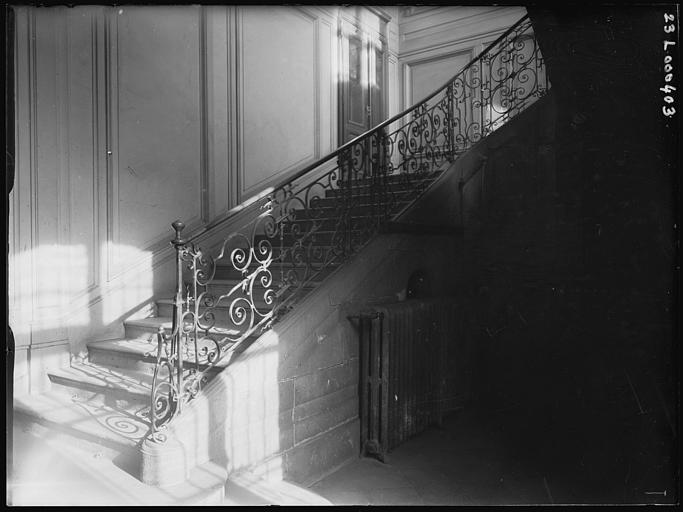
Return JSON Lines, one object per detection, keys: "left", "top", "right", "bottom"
{"left": 398, "top": 6, "right": 526, "bottom": 107}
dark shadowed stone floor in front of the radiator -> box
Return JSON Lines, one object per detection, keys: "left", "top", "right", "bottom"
{"left": 310, "top": 408, "right": 676, "bottom": 505}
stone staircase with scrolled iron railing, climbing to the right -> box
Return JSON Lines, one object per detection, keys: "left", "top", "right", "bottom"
{"left": 15, "top": 17, "right": 548, "bottom": 503}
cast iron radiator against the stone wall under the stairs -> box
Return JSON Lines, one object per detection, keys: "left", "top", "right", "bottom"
{"left": 349, "top": 299, "right": 470, "bottom": 461}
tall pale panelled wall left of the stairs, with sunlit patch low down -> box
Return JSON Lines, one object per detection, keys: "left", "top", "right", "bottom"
{"left": 9, "top": 6, "right": 398, "bottom": 393}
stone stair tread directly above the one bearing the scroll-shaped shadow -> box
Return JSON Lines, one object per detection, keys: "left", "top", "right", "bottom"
{"left": 49, "top": 362, "right": 152, "bottom": 397}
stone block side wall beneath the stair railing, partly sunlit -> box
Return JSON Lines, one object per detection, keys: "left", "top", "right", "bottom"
{"left": 141, "top": 229, "right": 460, "bottom": 486}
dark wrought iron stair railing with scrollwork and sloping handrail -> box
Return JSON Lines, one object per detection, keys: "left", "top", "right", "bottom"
{"left": 150, "top": 16, "right": 549, "bottom": 440}
